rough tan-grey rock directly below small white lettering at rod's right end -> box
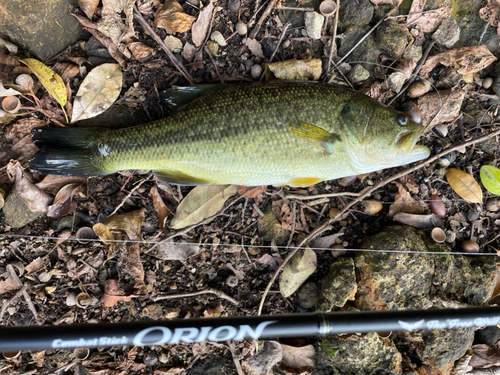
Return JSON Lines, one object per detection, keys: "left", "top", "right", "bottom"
{"left": 392, "top": 328, "right": 474, "bottom": 374}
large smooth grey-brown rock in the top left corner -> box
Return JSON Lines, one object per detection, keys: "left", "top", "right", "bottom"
{"left": 0, "top": 0, "right": 82, "bottom": 60}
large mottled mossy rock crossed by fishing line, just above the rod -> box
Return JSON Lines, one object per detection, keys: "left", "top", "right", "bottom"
{"left": 354, "top": 226, "right": 434, "bottom": 310}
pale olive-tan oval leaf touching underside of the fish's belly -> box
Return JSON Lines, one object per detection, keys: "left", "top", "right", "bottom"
{"left": 171, "top": 185, "right": 237, "bottom": 229}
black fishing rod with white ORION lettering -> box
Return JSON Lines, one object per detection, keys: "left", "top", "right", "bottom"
{"left": 0, "top": 306, "right": 500, "bottom": 352}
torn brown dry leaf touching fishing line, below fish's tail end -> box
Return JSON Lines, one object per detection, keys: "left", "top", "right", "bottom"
{"left": 92, "top": 208, "right": 144, "bottom": 244}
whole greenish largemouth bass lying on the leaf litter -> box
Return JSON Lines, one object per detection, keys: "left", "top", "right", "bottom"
{"left": 30, "top": 82, "right": 429, "bottom": 186}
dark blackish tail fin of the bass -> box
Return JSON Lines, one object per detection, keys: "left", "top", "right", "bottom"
{"left": 30, "top": 128, "right": 108, "bottom": 176}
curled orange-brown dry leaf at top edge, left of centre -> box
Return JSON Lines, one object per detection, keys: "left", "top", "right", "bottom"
{"left": 154, "top": 0, "right": 196, "bottom": 34}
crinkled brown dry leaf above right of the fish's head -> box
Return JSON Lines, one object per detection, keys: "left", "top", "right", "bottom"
{"left": 420, "top": 44, "right": 497, "bottom": 78}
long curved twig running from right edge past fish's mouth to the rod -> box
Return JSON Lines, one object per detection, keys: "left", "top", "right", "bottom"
{"left": 257, "top": 123, "right": 500, "bottom": 315}
